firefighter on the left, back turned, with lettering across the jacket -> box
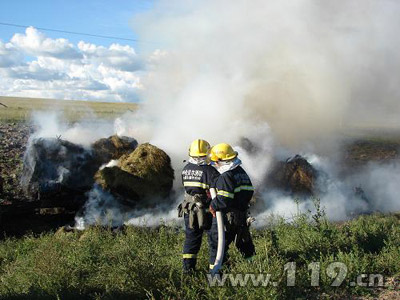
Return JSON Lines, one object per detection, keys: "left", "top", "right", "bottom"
{"left": 178, "top": 139, "right": 219, "bottom": 273}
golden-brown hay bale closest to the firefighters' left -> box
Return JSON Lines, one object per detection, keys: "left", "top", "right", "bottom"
{"left": 96, "top": 143, "right": 174, "bottom": 204}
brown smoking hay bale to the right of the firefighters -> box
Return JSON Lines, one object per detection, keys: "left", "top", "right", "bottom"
{"left": 267, "top": 155, "right": 317, "bottom": 197}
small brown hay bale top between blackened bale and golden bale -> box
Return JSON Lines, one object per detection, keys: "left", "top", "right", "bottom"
{"left": 92, "top": 135, "right": 138, "bottom": 164}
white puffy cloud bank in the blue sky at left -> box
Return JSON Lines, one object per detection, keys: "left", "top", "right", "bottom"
{"left": 0, "top": 27, "right": 150, "bottom": 101}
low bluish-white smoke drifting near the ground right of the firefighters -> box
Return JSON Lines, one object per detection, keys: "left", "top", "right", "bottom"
{"left": 255, "top": 155, "right": 400, "bottom": 227}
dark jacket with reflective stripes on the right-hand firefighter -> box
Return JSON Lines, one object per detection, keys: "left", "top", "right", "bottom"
{"left": 211, "top": 166, "right": 254, "bottom": 212}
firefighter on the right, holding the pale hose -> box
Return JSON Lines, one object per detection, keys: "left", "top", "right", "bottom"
{"left": 209, "top": 143, "right": 255, "bottom": 269}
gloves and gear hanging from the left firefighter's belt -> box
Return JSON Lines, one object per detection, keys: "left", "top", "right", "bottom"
{"left": 178, "top": 193, "right": 212, "bottom": 230}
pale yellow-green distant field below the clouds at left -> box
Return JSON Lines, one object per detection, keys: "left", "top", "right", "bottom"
{"left": 0, "top": 96, "right": 137, "bottom": 122}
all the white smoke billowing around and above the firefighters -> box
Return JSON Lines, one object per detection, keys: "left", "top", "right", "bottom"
{"left": 25, "top": 0, "right": 400, "bottom": 224}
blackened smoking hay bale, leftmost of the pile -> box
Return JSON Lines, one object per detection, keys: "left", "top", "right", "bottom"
{"left": 21, "top": 138, "right": 99, "bottom": 204}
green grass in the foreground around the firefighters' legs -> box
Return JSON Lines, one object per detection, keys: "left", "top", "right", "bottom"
{"left": 0, "top": 207, "right": 400, "bottom": 299}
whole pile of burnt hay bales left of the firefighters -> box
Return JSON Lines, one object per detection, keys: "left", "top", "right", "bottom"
{"left": 21, "top": 135, "right": 174, "bottom": 208}
